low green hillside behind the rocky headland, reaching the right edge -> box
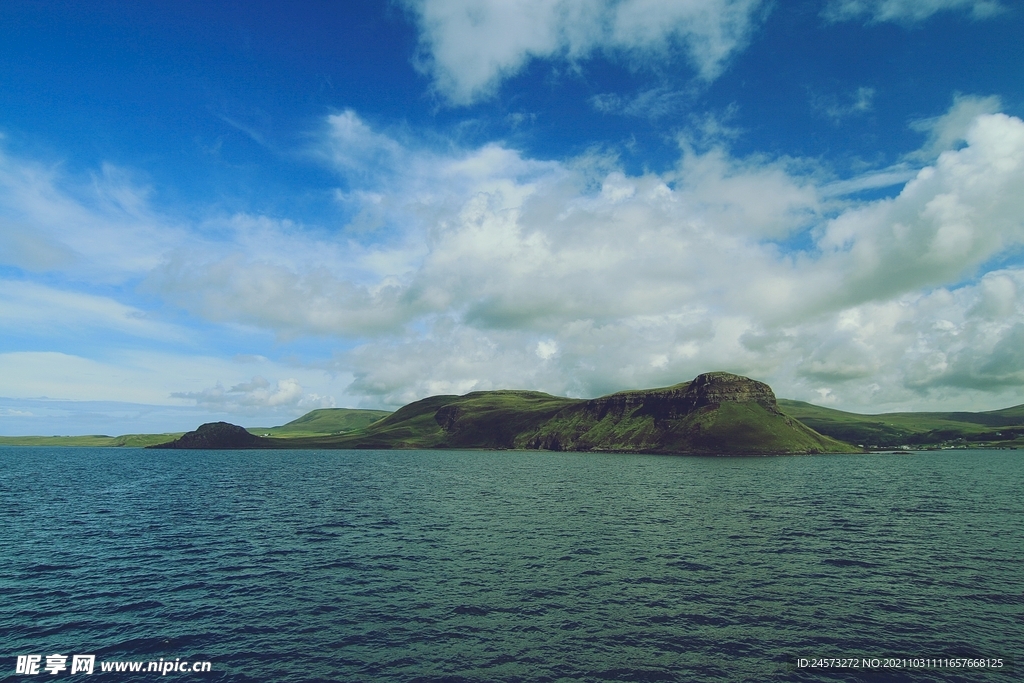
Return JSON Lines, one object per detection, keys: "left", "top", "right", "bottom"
{"left": 778, "top": 399, "right": 1024, "bottom": 447}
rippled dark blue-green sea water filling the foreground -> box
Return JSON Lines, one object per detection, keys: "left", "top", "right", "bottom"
{"left": 0, "top": 447, "right": 1024, "bottom": 682}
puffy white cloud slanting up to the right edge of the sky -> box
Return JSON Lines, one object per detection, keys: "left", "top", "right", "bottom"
{"left": 811, "top": 114, "right": 1024, "bottom": 310}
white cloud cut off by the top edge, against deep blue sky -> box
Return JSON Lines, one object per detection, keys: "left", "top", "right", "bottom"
{"left": 407, "top": 0, "right": 762, "bottom": 104}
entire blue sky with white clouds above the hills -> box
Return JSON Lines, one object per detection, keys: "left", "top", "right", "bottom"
{"left": 0, "top": 0, "right": 1024, "bottom": 435}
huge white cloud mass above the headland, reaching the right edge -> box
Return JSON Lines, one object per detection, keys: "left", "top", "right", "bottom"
{"left": 311, "top": 105, "right": 1024, "bottom": 408}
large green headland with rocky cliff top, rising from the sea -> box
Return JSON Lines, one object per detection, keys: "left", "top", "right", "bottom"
{"left": 256, "top": 373, "right": 857, "bottom": 455}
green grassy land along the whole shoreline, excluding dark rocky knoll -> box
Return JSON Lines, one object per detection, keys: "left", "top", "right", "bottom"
{"left": 6, "top": 373, "right": 1024, "bottom": 454}
